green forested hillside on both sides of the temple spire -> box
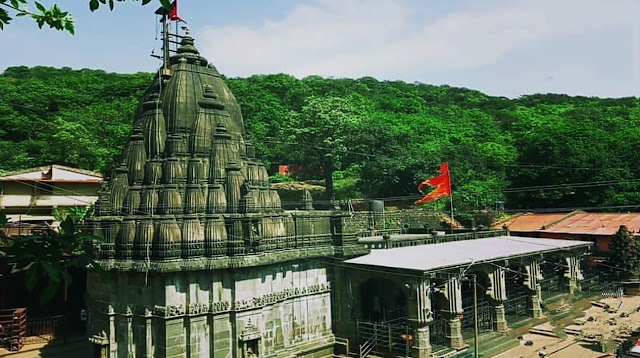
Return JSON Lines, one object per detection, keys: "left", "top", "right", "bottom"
{"left": 0, "top": 67, "right": 640, "bottom": 210}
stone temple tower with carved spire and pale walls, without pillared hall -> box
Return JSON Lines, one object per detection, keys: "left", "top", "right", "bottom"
{"left": 87, "top": 32, "right": 364, "bottom": 357}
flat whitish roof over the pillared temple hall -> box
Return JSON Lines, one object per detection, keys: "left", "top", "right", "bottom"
{"left": 345, "top": 236, "right": 591, "bottom": 272}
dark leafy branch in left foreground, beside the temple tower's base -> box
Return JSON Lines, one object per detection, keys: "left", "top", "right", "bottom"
{"left": 0, "top": 213, "right": 106, "bottom": 303}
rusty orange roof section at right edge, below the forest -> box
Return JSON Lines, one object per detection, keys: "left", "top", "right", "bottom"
{"left": 538, "top": 213, "right": 640, "bottom": 236}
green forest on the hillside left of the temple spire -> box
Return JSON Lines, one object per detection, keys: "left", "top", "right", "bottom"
{"left": 0, "top": 67, "right": 152, "bottom": 171}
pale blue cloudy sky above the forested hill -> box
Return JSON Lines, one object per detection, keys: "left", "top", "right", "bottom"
{"left": 0, "top": 0, "right": 640, "bottom": 98}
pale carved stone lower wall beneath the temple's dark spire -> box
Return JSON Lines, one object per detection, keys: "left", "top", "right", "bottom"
{"left": 87, "top": 261, "right": 333, "bottom": 358}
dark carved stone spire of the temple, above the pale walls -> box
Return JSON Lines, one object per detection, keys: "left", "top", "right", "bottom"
{"left": 88, "top": 34, "right": 284, "bottom": 260}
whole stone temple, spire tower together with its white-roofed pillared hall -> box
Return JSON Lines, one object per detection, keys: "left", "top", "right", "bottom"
{"left": 87, "top": 11, "right": 591, "bottom": 358}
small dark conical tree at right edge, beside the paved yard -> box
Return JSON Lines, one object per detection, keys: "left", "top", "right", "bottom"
{"left": 607, "top": 225, "right": 640, "bottom": 280}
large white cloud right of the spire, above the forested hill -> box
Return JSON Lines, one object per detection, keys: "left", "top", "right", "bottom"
{"left": 197, "top": 0, "right": 640, "bottom": 80}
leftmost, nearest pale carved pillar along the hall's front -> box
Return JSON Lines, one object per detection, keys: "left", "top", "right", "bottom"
{"left": 407, "top": 279, "right": 433, "bottom": 358}
